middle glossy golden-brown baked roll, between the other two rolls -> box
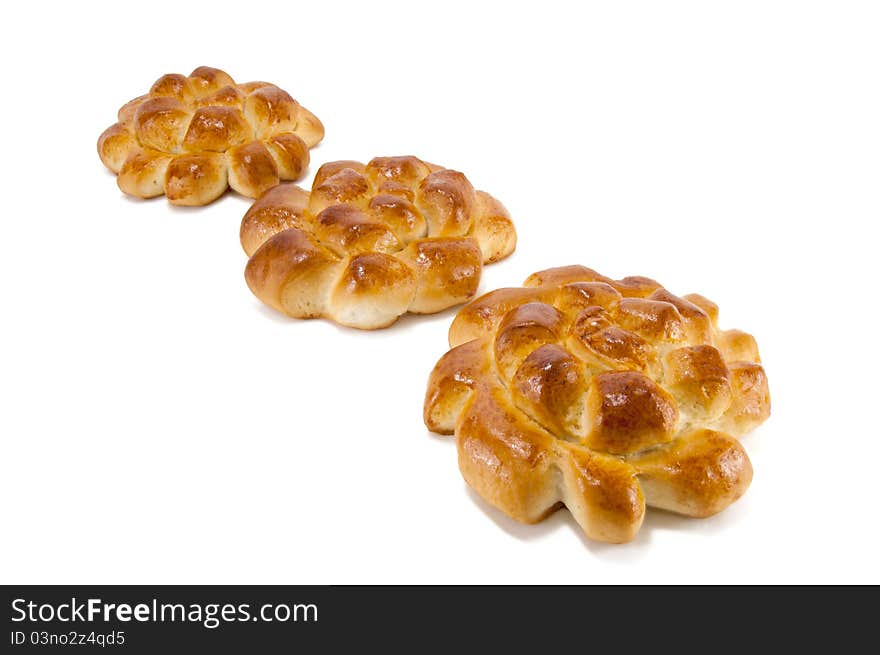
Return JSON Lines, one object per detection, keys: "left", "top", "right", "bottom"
{"left": 241, "top": 157, "right": 516, "bottom": 330}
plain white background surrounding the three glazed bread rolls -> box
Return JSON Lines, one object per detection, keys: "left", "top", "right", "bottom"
{"left": 0, "top": 0, "right": 880, "bottom": 583}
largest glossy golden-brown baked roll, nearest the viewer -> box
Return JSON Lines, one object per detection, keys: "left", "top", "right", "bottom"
{"left": 424, "top": 266, "right": 770, "bottom": 543}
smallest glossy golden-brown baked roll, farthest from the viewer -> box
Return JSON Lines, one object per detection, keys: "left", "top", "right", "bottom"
{"left": 98, "top": 66, "right": 324, "bottom": 205}
